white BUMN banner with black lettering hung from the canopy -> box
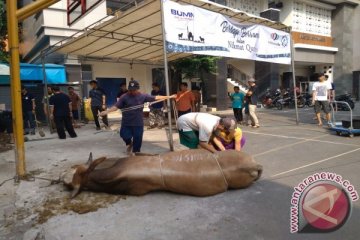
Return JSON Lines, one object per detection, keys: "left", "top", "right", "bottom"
{"left": 163, "top": 0, "right": 291, "bottom": 64}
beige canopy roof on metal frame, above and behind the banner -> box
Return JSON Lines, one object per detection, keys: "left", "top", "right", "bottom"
{"left": 55, "top": 0, "right": 288, "bottom": 63}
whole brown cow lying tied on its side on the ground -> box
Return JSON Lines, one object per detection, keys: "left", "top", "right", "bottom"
{"left": 62, "top": 149, "right": 262, "bottom": 197}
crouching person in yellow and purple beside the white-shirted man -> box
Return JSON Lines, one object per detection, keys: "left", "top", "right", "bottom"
{"left": 210, "top": 118, "right": 245, "bottom": 151}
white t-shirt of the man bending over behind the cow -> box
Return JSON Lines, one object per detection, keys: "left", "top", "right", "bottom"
{"left": 177, "top": 113, "right": 220, "bottom": 142}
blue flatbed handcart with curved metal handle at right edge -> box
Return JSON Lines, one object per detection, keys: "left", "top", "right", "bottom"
{"left": 329, "top": 101, "right": 360, "bottom": 137}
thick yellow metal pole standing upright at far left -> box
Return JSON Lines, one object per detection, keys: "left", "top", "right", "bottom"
{"left": 6, "top": 0, "right": 26, "bottom": 178}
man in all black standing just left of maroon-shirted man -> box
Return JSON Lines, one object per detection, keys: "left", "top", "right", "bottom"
{"left": 49, "top": 86, "right": 77, "bottom": 139}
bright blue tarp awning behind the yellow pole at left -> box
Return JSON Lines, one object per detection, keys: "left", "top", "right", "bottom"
{"left": 0, "top": 63, "right": 67, "bottom": 84}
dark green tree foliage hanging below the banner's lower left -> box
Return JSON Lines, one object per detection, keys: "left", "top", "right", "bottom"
{"left": 171, "top": 55, "right": 219, "bottom": 79}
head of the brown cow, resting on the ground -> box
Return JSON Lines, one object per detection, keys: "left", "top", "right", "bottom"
{"left": 60, "top": 153, "right": 106, "bottom": 198}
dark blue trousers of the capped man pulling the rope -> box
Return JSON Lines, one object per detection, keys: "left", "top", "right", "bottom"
{"left": 120, "top": 126, "right": 144, "bottom": 152}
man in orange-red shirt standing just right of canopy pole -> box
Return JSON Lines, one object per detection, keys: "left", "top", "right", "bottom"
{"left": 176, "top": 82, "right": 195, "bottom": 117}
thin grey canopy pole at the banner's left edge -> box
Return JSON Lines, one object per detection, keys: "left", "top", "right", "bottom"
{"left": 160, "top": 0, "right": 174, "bottom": 151}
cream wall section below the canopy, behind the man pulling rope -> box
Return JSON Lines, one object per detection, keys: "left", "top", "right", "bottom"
{"left": 83, "top": 61, "right": 163, "bottom": 93}
